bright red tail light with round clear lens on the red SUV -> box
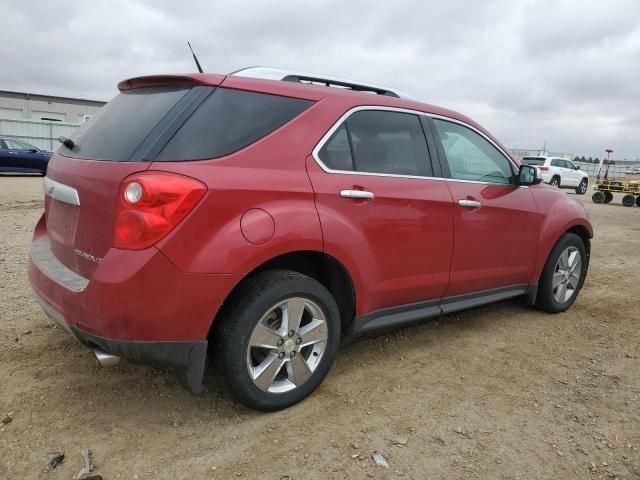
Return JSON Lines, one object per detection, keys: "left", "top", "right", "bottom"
{"left": 113, "top": 172, "right": 207, "bottom": 250}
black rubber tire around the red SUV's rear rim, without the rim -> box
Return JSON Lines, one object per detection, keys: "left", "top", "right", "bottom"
{"left": 213, "top": 270, "right": 341, "bottom": 411}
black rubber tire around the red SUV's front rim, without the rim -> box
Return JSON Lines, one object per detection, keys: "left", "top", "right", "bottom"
{"left": 536, "top": 233, "right": 589, "bottom": 313}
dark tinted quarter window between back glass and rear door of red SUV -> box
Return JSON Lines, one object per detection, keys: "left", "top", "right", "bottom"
{"left": 156, "top": 88, "right": 313, "bottom": 161}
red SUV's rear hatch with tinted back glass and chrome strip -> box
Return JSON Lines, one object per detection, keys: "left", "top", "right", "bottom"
{"left": 44, "top": 76, "right": 223, "bottom": 278}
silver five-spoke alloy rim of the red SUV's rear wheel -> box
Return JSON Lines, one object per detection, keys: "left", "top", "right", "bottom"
{"left": 247, "top": 297, "right": 329, "bottom": 393}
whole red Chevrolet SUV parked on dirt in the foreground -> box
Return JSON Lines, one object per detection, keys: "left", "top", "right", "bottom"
{"left": 29, "top": 68, "right": 592, "bottom": 410}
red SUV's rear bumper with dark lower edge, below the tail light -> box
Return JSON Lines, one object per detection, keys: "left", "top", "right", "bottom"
{"left": 29, "top": 223, "right": 240, "bottom": 393}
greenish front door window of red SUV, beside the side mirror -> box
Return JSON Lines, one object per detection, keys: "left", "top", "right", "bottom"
{"left": 434, "top": 119, "right": 514, "bottom": 184}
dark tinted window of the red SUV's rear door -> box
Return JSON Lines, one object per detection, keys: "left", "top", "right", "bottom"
{"left": 319, "top": 110, "right": 432, "bottom": 176}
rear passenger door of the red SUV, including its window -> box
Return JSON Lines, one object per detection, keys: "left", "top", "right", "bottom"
{"left": 307, "top": 107, "right": 453, "bottom": 315}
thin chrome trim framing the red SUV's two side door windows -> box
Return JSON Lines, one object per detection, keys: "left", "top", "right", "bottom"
{"left": 311, "top": 105, "right": 529, "bottom": 188}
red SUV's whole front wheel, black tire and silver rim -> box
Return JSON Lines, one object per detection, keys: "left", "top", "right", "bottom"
{"left": 537, "top": 233, "right": 588, "bottom": 313}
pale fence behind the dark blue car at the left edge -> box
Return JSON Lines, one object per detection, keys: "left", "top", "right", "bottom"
{"left": 0, "top": 118, "right": 80, "bottom": 151}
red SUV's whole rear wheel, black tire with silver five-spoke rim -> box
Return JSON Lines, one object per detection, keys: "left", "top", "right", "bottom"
{"left": 214, "top": 270, "right": 340, "bottom": 411}
